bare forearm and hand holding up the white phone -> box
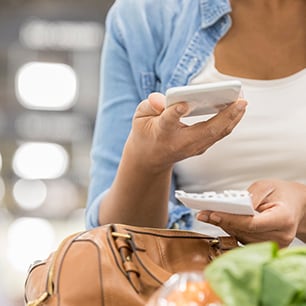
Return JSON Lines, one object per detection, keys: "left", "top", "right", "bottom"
{"left": 99, "top": 93, "right": 246, "bottom": 227}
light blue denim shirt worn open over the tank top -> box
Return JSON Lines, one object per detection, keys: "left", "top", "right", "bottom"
{"left": 86, "top": 0, "right": 231, "bottom": 229}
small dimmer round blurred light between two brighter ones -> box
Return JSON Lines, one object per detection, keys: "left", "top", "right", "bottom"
{"left": 13, "top": 179, "right": 47, "bottom": 210}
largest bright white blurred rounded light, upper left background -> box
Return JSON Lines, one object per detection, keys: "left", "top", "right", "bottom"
{"left": 15, "top": 62, "right": 78, "bottom": 110}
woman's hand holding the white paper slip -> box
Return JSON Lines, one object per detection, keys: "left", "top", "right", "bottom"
{"left": 197, "top": 180, "right": 306, "bottom": 247}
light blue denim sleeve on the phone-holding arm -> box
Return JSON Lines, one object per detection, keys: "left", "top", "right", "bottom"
{"left": 86, "top": 2, "right": 141, "bottom": 228}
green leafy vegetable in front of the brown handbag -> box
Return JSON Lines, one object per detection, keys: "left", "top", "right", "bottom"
{"left": 204, "top": 242, "right": 306, "bottom": 306}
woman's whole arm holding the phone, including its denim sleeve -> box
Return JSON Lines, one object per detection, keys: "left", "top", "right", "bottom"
{"left": 86, "top": 1, "right": 246, "bottom": 227}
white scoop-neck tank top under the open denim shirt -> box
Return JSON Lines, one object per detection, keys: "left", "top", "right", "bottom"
{"left": 175, "top": 58, "right": 306, "bottom": 241}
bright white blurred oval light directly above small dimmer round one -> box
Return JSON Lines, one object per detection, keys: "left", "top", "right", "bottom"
{"left": 13, "top": 142, "right": 68, "bottom": 179}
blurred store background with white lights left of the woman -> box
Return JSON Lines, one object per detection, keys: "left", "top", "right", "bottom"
{"left": 0, "top": 0, "right": 113, "bottom": 306}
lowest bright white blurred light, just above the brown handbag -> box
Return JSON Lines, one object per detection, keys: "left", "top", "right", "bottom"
{"left": 7, "top": 218, "right": 55, "bottom": 272}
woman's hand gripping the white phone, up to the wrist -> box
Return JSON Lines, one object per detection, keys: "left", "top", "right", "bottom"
{"left": 127, "top": 93, "right": 247, "bottom": 172}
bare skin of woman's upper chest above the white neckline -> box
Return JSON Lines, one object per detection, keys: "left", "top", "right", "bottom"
{"left": 214, "top": 1, "right": 306, "bottom": 80}
